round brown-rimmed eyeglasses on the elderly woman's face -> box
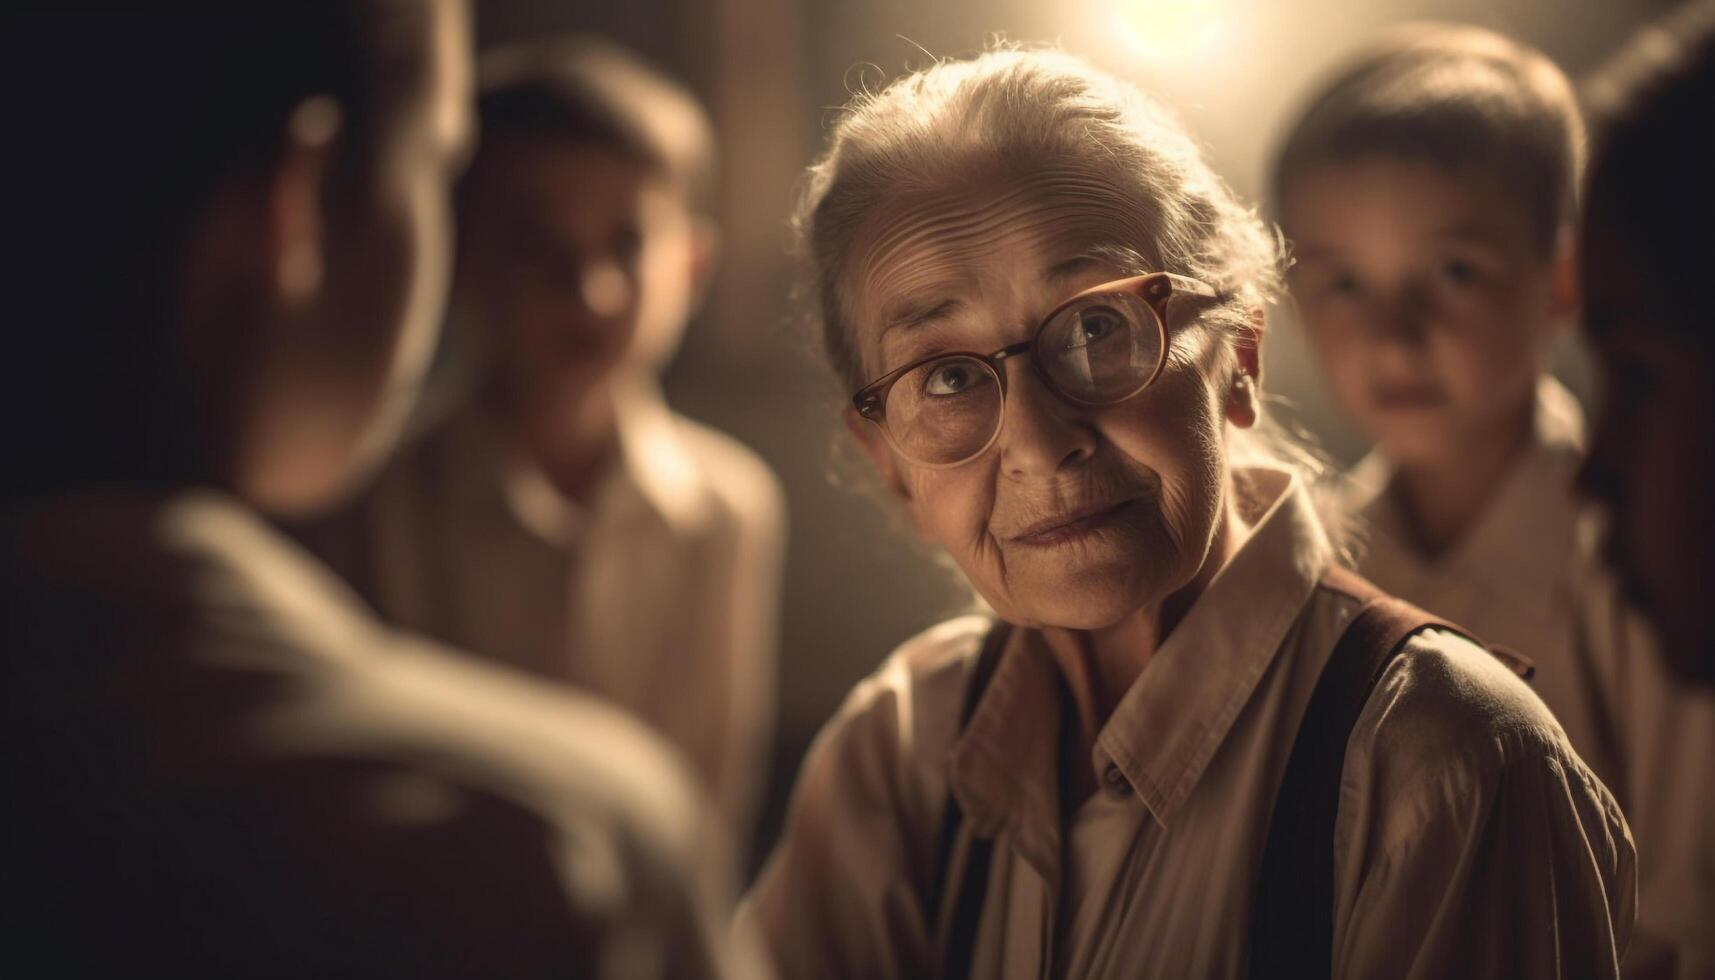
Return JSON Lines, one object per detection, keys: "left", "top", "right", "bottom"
{"left": 852, "top": 273, "right": 1218, "bottom": 469}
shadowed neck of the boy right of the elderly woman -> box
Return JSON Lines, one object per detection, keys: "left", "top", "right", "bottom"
{"left": 1387, "top": 393, "right": 1535, "bottom": 558}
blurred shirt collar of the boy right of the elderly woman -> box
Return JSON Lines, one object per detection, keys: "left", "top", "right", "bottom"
{"left": 1348, "top": 376, "right": 1585, "bottom": 592}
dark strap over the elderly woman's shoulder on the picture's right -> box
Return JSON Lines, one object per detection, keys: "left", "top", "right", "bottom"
{"left": 1250, "top": 568, "right": 1530, "bottom": 978}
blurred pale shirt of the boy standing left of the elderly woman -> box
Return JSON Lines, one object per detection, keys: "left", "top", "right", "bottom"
{"left": 309, "top": 378, "right": 784, "bottom": 831}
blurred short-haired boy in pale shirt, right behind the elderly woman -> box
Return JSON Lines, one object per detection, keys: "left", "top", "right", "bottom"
{"left": 1273, "top": 24, "right": 1715, "bottom": 977}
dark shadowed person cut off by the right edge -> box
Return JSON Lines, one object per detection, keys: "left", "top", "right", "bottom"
{"left": 1580, "top": 2, "right": 1715, "bottom": 977}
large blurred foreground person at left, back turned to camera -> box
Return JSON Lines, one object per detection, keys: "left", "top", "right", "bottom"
{"left": 0, "top": 0, "right": 758, "bottom": 978}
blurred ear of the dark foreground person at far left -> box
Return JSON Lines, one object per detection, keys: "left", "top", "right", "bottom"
{"left": 261, "top": 96, "right": 341, "bottom": 307}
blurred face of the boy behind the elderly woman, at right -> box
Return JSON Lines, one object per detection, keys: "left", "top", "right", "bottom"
{"left": 1283, "top": 156, "right": 1569, "bottom": 467}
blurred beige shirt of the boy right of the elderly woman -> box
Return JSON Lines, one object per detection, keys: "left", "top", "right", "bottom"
{"left": 1348, "top": 378, "right": 1715, "bottom": 980}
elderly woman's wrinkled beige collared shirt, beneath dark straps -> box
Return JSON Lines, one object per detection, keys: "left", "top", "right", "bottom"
{"left": 741, "top": 470, "right": 1634, "bottom": 978}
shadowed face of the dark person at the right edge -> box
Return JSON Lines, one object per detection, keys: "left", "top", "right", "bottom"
{"left": 1580, "top": 211, "right": 1715, "bottom": 683}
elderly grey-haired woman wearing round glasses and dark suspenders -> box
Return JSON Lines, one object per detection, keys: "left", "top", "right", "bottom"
{"left": 741, "top": 51, "right": 1633, "bottom": 977}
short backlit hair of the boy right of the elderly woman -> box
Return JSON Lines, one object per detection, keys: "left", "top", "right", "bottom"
{"left": 1271, "top": 24, "right": 1585, "bottom": 256}
